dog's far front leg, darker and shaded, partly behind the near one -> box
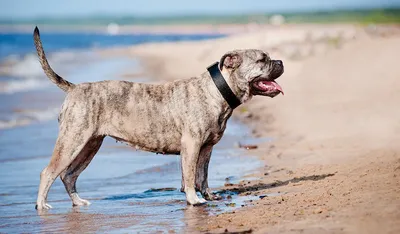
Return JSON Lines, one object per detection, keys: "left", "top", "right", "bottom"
{"left": 196, "top": 145, "right": 221, "bottom": 201}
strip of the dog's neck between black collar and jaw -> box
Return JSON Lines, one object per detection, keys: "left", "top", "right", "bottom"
{"left": 221, "top": 68, "right": 251, "bottom": 103}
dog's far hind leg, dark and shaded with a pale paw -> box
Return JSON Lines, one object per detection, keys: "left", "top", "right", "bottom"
{"left": 60, "top": 136, "right": 104, "bottom": 206}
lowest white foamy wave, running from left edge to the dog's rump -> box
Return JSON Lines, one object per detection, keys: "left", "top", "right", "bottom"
{"left": 0, "top": 107, "right": 60, "bottom": 129}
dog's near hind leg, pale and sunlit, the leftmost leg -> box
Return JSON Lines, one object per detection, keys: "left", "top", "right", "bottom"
{"left": 36, "top": 130, "right": 95, "bottom": 210}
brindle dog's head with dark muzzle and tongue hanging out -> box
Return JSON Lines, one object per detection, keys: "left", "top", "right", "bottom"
{"left": 219, "top": 50, "right": 283, "bottom": 99}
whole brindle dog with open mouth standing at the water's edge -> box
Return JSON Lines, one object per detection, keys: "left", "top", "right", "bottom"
{"left": 33, "top": 27, "right": 284, "bottom": 210}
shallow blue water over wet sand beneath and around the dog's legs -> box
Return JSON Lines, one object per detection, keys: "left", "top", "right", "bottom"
{"left": 0, "top": 122, "right": 262, "bottom": 233}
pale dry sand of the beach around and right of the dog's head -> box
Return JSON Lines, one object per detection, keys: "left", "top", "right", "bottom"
{"left": 104, "top": 25, "right": 400, "bottom": 233}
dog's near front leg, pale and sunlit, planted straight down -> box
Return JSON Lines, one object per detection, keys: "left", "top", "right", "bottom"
{"left": 181, "top": 135, "right": 206, "bottom": 205}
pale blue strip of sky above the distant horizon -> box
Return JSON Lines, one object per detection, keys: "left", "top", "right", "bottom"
{"left": 0, "top": 0, "right": 400, "bottom": 19}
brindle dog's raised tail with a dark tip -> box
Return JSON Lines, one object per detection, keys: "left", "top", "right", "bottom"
{"left": 33, "top": 27, "right": 75, "bottom": 92}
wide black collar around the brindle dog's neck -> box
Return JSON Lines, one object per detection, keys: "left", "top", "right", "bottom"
{"left": 207, "top": 62, "right": 241, "bottom": 109}
